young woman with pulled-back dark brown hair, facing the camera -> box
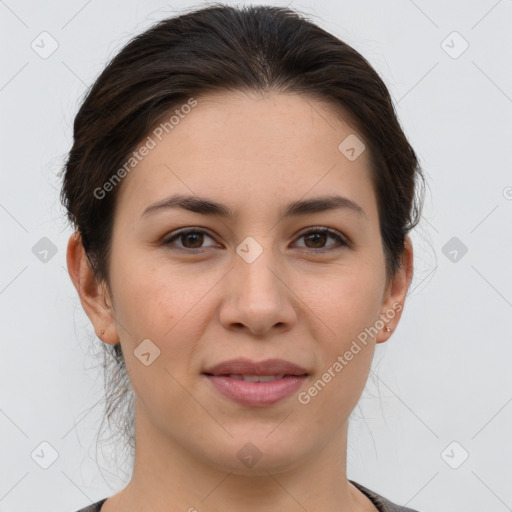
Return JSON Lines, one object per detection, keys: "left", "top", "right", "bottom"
{"left": 62, "top": 4, "right": 423, "bottom": 512}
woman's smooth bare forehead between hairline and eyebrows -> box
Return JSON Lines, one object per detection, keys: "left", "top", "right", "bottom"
{"left": 116, "top": 92, "right": 376, "bottom": 225}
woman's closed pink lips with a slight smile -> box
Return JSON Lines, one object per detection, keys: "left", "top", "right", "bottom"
{"left": 204, "top": 359, "right": 308, "bottom": 407}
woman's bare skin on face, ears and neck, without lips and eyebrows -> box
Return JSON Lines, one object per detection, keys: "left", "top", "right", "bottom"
{"left": 67, "top": 92, "right": 413, "bottom": 512}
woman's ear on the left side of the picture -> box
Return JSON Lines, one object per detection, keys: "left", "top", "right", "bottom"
{"left": 66, "top": 232, "right": 119, "bottom": 344}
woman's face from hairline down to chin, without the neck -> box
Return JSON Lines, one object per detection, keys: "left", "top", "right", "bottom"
{"left": 70, "top": 93, "right": 409, "bottom": 474}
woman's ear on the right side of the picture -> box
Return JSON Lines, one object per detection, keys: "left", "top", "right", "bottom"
{"left": 375, "top": 235, "right": 414, "bottom": 343}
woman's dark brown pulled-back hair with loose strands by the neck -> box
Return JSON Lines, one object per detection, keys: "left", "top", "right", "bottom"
{"left": 61, "top": 4, "right": 424, "bottom": 460}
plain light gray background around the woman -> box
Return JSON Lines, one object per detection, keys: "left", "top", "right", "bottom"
{"left": 0, "top": 0, "right": 512, "bottom": 512}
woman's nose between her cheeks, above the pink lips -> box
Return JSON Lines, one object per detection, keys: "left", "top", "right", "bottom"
{"left": 220, "top": 243, "right": 297, "bottom": 337}
